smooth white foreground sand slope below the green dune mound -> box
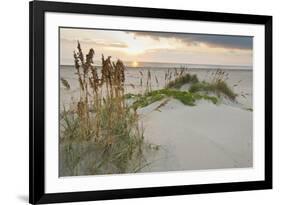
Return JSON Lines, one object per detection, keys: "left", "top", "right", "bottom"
{"left": 139, "top": 99, "right": 253, "bottom": 171}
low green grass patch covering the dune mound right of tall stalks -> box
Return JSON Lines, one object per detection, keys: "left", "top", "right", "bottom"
{"left": 124, "top": 68, "right": 232, "bottom": 110}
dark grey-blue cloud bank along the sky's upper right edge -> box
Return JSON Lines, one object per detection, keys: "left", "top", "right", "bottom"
{"left": 127, "top": 32, "right": 253, "bottom": 50}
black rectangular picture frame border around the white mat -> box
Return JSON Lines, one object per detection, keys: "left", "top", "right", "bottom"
{"left": 29, "top": 1, "right": 272, "bottom": 204}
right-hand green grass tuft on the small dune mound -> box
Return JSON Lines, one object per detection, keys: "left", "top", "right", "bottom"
{"left": 189, "top": 81, "right": 237, "bottom": 101}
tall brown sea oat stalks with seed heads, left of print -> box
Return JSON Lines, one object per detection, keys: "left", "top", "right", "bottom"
{"left": 62, "top": 42, "right": 127, "bottom": 142}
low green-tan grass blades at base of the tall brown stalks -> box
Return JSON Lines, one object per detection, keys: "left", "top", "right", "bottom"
{"left": 60, "top": 107, "right": 149, "bottom": 176}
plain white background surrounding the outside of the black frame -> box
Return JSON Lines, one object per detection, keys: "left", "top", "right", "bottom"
{"left": 0, "top": 0, "right": 281, "bottom": 205}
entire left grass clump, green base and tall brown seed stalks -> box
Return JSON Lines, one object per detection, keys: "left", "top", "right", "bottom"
{"left": 59, "top": 42, "right": 156, "bottom": 176}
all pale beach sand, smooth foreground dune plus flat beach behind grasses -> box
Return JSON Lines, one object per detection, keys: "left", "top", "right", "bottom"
{"left": 60, "top": 66, "right": 253, "bottom": 172}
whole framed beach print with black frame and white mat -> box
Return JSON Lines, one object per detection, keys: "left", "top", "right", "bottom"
{"left": 30, "top": 1, "right": 272, "bottom": 204}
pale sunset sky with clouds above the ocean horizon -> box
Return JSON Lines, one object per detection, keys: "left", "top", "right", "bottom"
{"left": 60, "top": 28, "right": 253, "bottom": 66}
